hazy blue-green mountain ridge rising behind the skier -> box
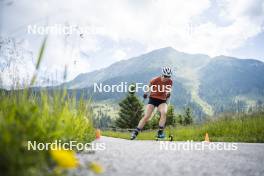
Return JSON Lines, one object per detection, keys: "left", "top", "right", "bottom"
{"left": 64, "top": 47, "right": 264, "bottom": 116}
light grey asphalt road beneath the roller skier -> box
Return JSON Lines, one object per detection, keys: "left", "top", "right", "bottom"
{"left": 78, "top": 137, "right": 264, "bottom": 176}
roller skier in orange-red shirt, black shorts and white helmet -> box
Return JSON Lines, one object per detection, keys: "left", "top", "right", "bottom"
{"left": 130, "top": 67, "right": 172, "bottom": 140}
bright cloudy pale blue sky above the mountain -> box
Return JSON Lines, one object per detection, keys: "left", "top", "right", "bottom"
{"left": 0, "top": 0, "right": 264, "bottom": 87}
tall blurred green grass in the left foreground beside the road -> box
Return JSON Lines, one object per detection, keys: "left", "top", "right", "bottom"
{"left": 0, "top": 90, "right": 95, "bottom": 176}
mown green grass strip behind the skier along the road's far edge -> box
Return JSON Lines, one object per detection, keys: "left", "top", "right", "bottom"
{"left": 102, "top": 112, "right": 264, "bottom": 142}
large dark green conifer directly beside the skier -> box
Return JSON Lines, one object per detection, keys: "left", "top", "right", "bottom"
{"left": 116, "top": 85, "right": 144, "bottom": 128}
